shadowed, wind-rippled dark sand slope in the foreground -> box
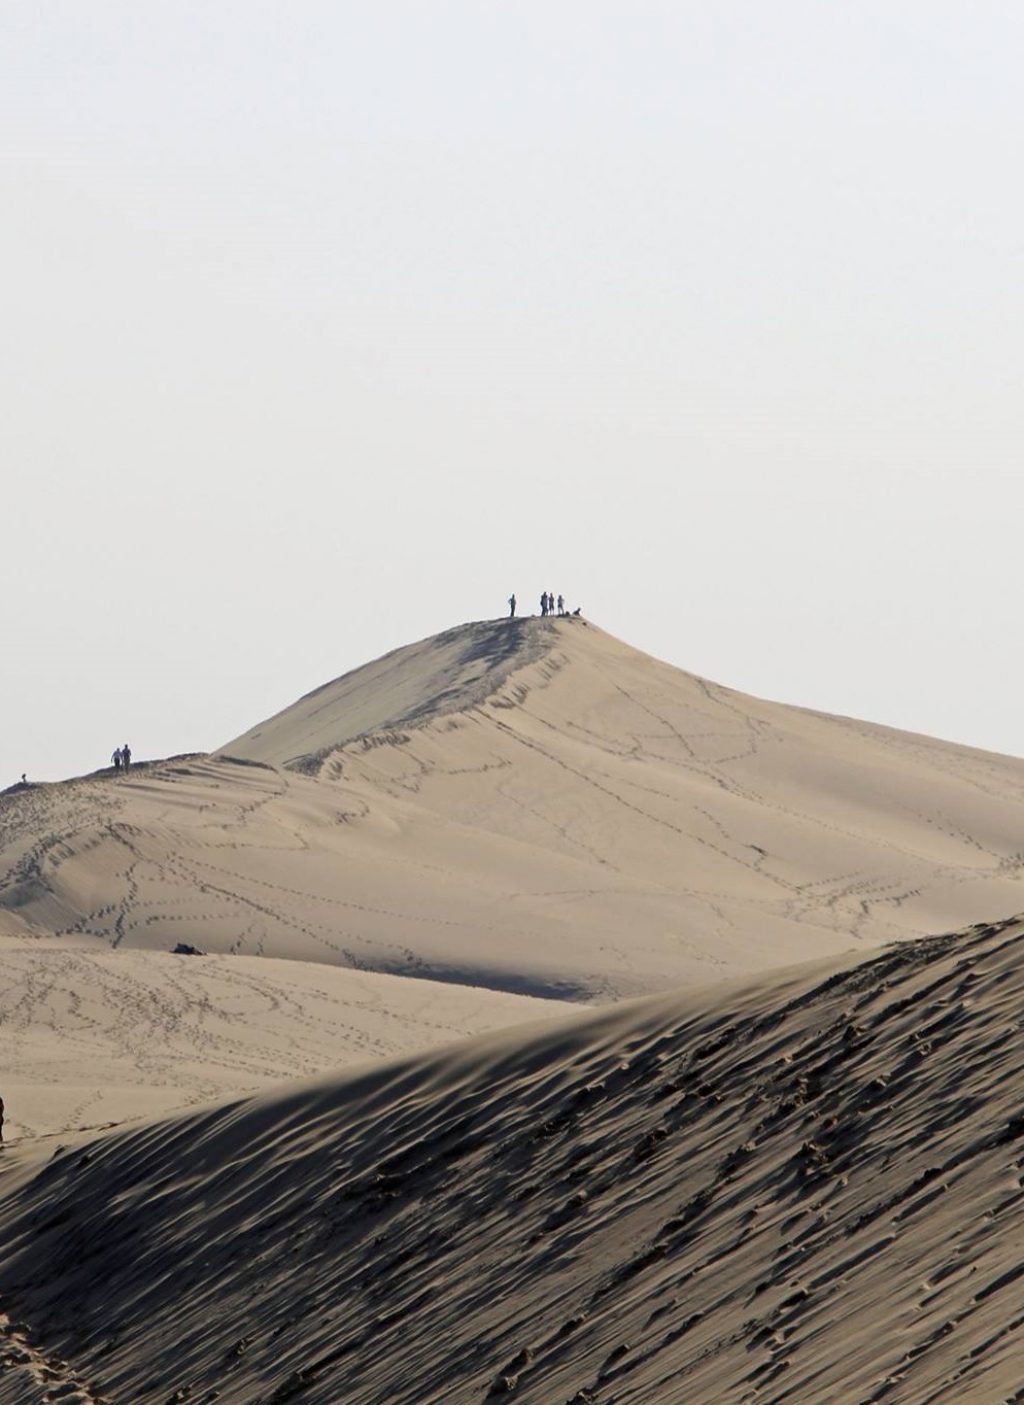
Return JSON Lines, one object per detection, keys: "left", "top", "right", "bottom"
{"left": 0, "top": 920, "right": 1024, "bottom": 1405}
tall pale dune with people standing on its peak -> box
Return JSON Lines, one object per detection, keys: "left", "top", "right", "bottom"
{"left": 0, "top": 620, "right": 1024, "bottom": 1000}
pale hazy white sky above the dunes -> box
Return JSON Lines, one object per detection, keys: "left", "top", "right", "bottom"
{"left": 0, "top": 0, "right": 1024, "bottom": 787}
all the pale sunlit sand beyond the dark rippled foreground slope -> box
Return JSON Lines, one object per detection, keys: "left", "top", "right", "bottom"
{"left": 0, "top": 609, "right": 1024, "bottom": 1132}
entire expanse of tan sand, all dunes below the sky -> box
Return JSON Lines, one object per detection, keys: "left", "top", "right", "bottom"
{"left": 0, "top": 620, "right": 1024, "bottom": 1405}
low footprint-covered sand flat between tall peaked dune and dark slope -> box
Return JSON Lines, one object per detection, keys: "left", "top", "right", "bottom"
{"left": 0, "top": 939, "right": 565, "bottom": 1141}
